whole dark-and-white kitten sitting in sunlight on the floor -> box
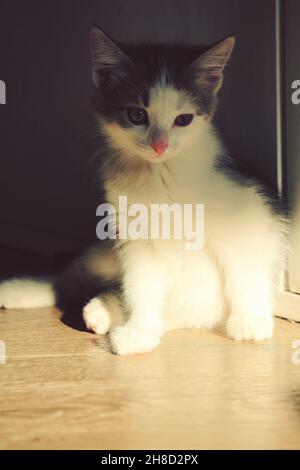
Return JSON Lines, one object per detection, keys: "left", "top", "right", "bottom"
{"left": 0, "top": 28, "right": 286, "bottom": 355}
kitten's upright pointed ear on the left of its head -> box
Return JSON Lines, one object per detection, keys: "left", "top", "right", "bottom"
{"left": 90, "top": 26, "right": 132, "bottom": 87}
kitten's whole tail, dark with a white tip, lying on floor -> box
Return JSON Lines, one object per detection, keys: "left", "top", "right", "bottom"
{"left": 0, "top": 247, "right": 119, "bottom": 309}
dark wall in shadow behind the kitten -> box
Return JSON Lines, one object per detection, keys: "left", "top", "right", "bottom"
{"left": 0, "top": 0, "right": 276, "bottom": 253}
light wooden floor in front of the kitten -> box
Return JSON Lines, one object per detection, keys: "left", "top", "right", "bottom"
{"left": 0, "top": 310, "right": 300, "bottom": 449}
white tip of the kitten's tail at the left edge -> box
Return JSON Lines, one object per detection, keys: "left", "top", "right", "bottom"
{"left": 0, "top": 278, "right": 56, "bottom": 309}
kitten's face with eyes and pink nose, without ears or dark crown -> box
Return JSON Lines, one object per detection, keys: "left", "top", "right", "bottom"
{"left": 102, "top": 81, "right": 205, "bottom": 163}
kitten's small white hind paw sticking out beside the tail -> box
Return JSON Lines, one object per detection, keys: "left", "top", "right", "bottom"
{"left": 83, "top": 297, "right": 111, "bottom": 335}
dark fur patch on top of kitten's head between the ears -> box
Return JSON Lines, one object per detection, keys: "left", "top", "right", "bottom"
{"left": 94, "top": 44, "right": 216, "bottom": 127}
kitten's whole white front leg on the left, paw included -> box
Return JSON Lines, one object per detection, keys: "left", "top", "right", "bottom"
{"left": 111, "top": 243, "right": 167, "bottom": 355}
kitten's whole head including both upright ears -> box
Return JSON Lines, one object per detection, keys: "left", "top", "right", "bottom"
{"left": 91, "top": 28, "right": 234, "bottom": 163}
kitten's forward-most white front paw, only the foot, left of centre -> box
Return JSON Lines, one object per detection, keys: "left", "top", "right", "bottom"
{"left": 110, "top": 326, "right": 160, "bottom": 356}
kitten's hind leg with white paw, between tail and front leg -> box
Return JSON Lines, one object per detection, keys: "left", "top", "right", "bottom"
{"left": 83, "top": 294, "right": 124, "bottom": 335}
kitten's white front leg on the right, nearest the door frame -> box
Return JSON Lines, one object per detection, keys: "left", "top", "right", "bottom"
{"left": 225, "top": 253, "right": 273, "bottom": 341}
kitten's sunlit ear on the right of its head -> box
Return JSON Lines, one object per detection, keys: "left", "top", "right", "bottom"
{"left": 191, "top": 36, "right": 235, "bottom": 93}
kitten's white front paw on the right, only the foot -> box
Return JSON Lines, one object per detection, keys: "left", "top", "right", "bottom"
{"left": 227, "top": 315, "right": 273, "bottom": 341}
